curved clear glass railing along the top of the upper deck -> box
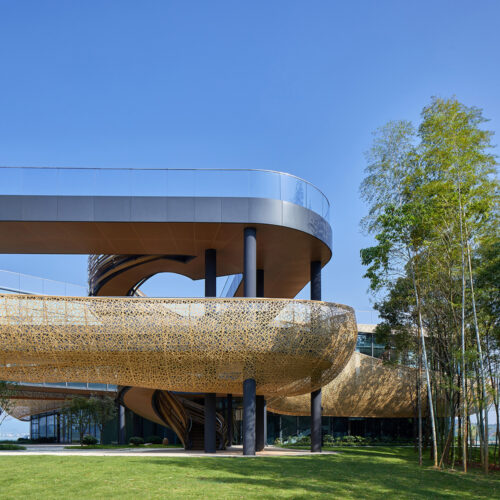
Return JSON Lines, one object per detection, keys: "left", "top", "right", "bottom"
{"left": 0, "top": 167, "right": 330, "bottom": 219}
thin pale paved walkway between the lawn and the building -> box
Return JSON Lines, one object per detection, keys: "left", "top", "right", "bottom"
{"left": 0, "top": 444, "right": 336, "bottom": 458}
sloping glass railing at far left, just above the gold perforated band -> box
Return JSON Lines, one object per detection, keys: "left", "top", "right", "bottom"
{"left": 0, "top": 269, "right": 88, "bottom": 297}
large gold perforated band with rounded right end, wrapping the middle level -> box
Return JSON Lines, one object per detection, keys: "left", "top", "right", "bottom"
{"left": 0, "top": 295, "right": 357, "bottom": 395}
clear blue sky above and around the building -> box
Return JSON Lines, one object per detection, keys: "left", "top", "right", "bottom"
{"left": 0, "top": 0, "right": 500, "bottom": 436}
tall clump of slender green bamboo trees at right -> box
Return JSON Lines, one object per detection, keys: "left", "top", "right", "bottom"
{"left": 361, "top": 94, "right": 500, "bottom": 471}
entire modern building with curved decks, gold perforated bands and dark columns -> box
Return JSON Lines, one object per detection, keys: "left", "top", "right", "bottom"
{"left": 0, "top": 168, "right": 414, "bottom": 455}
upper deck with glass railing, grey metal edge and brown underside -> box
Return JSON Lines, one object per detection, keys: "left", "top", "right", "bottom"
{"left": 0, "top": 167, "right": 332, "bottom": 297}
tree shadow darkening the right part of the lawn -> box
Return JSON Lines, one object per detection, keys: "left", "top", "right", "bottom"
{"left": 131, "top": 449, "right": 500, "bottom": 499}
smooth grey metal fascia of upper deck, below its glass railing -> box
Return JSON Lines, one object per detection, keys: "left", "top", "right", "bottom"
{"left": 0, "top": 195, "right": 332, "bottom": 248}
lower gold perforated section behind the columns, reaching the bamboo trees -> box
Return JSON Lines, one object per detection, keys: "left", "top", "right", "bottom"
{"left": 267, "top": 352, "right": 420, "bottom": 418}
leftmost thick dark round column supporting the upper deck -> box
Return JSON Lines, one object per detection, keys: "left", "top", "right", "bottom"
{"left": 204, "top": 248, "right": 217, "bottom": 453}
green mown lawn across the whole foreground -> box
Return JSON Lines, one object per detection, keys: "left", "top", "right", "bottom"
{"left": 0, "top": 447, "right": 500, "bottom": 500}
